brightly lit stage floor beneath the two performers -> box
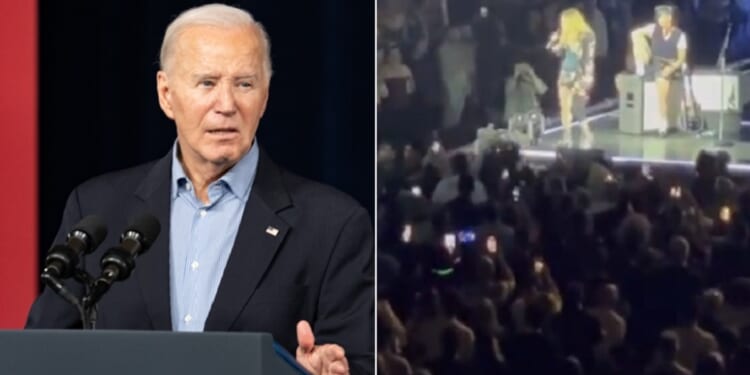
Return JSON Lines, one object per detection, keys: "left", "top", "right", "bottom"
{"left": 523, "top": 111, "right": 750, "bottom": 164}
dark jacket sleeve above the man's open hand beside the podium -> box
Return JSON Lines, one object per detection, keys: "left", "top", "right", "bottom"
{"left": 313, "top": 207, "right": 375, "bottom": 375}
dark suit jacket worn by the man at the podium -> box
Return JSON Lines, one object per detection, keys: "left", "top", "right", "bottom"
{"left": 27, "top": 151, "right": 375, "bottom": 374}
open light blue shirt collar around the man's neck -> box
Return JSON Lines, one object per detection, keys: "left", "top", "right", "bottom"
{"left": 172, "top": 140, "right": 260, "bottom": 202}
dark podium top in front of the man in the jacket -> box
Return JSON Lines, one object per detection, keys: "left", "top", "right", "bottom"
{"left": 0, "top": 330, "right": 308, "bottom": 375}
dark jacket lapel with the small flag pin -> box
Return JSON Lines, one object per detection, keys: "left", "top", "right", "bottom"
{"left": 204, "top": 149, "right": 291, "bottom": 331}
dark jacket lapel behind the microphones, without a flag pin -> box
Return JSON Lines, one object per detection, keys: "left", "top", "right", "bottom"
{"left": 134, "top": 152, "right": 172, "bottom": 331}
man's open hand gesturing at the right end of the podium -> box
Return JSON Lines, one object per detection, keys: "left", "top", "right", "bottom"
{"left": 297, "top": 320, "right": 349, "bottom": 375}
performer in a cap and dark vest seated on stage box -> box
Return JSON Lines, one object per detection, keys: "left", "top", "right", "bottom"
{"left": 631, "top": 5, "right": 688, "bottom": 135}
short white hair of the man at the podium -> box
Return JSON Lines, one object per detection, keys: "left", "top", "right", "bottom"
{"left": 159, "top": 4, "right": 273, "bottom": 80}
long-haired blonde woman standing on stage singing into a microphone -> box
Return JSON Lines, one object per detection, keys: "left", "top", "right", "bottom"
{"left": 547, "top": 8, "right": 596, "bottom": 148}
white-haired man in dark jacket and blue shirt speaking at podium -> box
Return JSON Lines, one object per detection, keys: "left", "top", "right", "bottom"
{"left": 27, "top": 4, "right": 374, "bottom": 374}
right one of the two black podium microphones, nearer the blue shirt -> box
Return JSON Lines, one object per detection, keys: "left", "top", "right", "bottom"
{"left": 86, "top": 214, "right": 161, "bottom": 306}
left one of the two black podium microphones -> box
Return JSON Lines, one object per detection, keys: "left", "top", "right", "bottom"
{"left": 42, "top": 215, "right": 107, "bottom": 280}
